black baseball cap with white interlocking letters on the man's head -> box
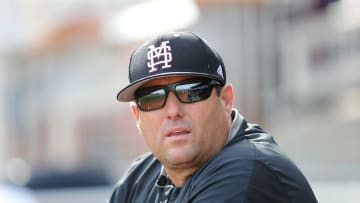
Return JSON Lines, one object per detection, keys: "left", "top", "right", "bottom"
{"left": 117, "top": 32, "right": 226, "bottom": 102}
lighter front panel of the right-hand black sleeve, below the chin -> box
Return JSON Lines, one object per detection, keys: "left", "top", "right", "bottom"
{"left": 188, "top": 141, "right": 256, "bottom": 202}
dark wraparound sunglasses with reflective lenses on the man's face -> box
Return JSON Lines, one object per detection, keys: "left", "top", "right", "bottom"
{"left": 135, "top": 78, "right": 222, "bottom": 111}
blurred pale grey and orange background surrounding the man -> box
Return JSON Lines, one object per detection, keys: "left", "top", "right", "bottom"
{"left": 0, "top": 0, "right": 360, "bottom": 203}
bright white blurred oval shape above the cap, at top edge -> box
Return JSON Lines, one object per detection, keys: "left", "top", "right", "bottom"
{"left": 103, "top": 0, "right": 199, "bottom": 44}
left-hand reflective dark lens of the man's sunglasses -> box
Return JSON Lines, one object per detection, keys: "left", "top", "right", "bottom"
{"left": 136, "top": 89, "right": 166, "bottom": 111}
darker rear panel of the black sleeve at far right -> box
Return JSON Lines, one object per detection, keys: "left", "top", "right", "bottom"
{"left": 247, "top": 143, "right": 316, "bottom": 203}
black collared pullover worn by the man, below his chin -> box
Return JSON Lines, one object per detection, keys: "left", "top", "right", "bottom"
{"left": 109, "top": 110, "right": 317, "bottom": 203}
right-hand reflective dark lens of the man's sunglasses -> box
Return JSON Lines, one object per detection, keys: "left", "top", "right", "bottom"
{"left": 176, "top": 82, "right": 212, "bottom": 103}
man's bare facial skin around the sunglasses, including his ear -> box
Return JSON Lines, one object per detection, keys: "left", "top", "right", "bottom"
{"left": 131, "top": 76, "right": 233, "bottom": 169}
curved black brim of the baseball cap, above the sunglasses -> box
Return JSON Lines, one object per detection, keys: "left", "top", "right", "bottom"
{"left": 116, "top": 72, "right": 221, "bottom": 102}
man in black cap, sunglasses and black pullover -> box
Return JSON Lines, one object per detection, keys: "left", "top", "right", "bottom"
{"left": 109, "top": 32, "right": 317, "bottom": 203}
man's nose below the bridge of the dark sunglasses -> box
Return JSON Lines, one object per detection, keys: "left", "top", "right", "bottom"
{"left": 165, "top": 92, "right": 184, "bottom": 119}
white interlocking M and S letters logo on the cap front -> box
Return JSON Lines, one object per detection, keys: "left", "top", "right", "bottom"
{"left": 147, "top": 41, "right": 172, "bottom": 73}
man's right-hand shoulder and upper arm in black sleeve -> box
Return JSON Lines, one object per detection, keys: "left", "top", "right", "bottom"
{"left": 187, "top": 135, "right": 316, "bottom": 202}
